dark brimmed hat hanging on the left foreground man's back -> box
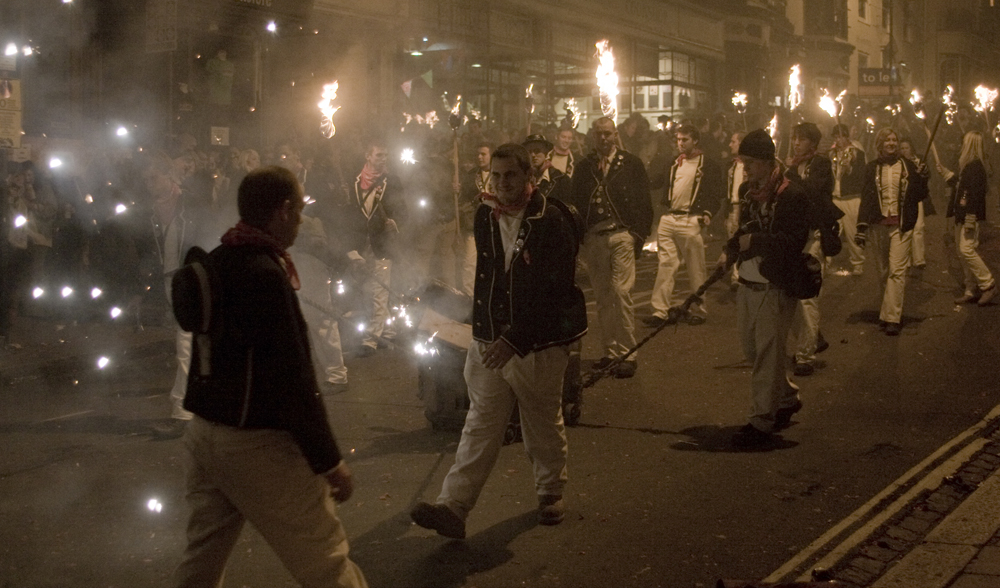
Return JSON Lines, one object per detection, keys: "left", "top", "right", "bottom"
{"left": 170, "top": 246, "right": 222, "bottom": 376}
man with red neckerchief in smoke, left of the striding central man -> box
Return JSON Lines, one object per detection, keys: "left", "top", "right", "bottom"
{"left": 343, "top": 141, "right": 406, "bottom": 357}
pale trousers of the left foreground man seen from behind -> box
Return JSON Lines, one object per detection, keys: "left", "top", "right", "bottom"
{"left": 174, "top": 417, "right": 368, "bottom": 588}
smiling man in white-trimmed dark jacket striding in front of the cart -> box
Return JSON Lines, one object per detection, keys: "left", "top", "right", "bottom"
{"left": 410, "top": 143, "right": 587, "bottom": 539}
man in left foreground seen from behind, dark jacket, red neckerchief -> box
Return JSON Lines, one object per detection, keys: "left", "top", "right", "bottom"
{"left": 174, "top": 167, "right": 367, "bottom": 588}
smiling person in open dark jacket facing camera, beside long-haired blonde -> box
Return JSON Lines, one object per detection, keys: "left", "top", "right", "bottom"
{"left": 854, "top": 128, "right": 927, "bottom": 337}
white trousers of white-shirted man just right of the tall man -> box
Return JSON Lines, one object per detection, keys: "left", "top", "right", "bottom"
{"left": 649, "top": 214, "right": 707, "bottom": 318}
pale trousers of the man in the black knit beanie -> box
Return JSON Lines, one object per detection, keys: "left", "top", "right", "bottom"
{"left": 736, "top": 284, "right": 799, "bottom": 432}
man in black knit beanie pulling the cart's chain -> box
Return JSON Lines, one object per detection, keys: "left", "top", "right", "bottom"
{"left": 719, "top": 129, "right": 809, "bottom": 447}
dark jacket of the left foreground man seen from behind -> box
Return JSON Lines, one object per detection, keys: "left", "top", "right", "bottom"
{"left": 184, "top": 245, "right": 341, "bottom": 474}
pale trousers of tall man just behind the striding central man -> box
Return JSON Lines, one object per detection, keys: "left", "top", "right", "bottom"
{"left": 580, "top": 230, "right": 636, "bottom": 359}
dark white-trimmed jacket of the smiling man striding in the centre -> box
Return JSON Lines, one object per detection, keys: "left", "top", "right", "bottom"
{"left": 472, "top": 190, "right": 587, "bottom": 357}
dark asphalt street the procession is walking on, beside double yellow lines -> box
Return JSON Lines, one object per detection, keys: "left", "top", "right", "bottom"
{"left": 0, "top": 211, "right": 1000, "bottom": 588}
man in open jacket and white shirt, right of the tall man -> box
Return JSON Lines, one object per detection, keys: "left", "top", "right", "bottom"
{"left": 643, "top": 126, "right": 723, "bottom": 327}
